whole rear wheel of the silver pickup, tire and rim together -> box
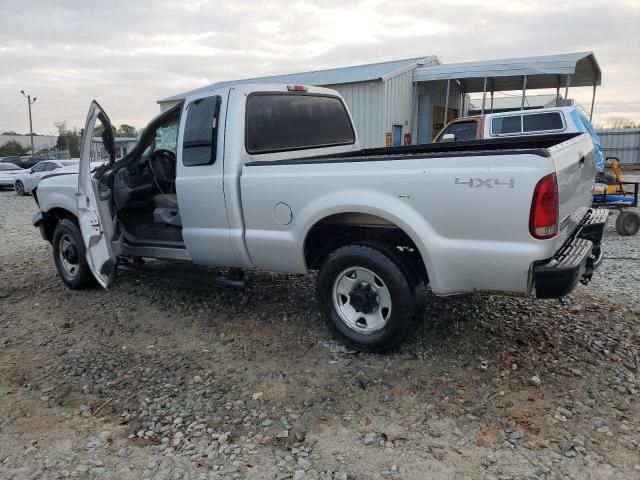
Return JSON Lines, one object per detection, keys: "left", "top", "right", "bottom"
{"left": 316, "top": 244, "right": 425, "bottom": 352}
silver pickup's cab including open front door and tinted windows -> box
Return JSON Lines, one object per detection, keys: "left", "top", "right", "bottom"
{"left": 63, "top": 85, "right": 360, "bottom": 287}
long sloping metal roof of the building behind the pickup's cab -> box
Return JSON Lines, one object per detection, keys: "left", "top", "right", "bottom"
{"left": 159, "top": 56, "right": 440, "bottom": 102}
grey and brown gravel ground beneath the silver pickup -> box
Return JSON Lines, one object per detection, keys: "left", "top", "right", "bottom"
{"left": 0, "top": 191, "right": 640, "bottom": 480}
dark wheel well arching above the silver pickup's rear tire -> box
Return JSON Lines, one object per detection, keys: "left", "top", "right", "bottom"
{"left": 304, "top": 212, "right": 428, "bottom": 282}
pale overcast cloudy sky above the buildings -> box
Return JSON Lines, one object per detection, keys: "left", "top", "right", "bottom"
{"left": 0, "top": 0, "right": 640, "bottom": 134}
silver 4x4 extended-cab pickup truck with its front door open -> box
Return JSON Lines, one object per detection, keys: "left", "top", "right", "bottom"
{"left": 34, "top": 85, "right": 606, "bottom": 351}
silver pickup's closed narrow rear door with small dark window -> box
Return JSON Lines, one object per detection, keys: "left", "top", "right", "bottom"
{"left": 176, "top": 94, "right": 243, "bottom": 267}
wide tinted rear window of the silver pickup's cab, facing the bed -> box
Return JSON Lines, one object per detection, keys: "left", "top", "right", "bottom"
{"left": 245, "top": 93, "right": 355, "bottom": 154}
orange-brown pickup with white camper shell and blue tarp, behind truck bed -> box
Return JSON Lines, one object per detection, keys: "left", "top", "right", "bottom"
{"left": 434, "top": 106, "right": 605, "bottom": 171}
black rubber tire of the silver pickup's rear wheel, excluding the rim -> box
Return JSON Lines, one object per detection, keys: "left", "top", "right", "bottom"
{"left": 316, "top": 244, "right": 426, "bottom": 353}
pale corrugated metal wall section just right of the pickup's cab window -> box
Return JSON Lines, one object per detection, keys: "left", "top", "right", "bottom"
{"left": 326, "top": 80, "right": 384, "bottom": 148}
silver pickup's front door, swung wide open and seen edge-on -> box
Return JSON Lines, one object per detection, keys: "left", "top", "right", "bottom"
{"left": 77, "top": 100, "right": 117, "bottom": 288}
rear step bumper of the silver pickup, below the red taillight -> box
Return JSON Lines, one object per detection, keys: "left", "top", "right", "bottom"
{"left": 533, "top": 208, "right": 609, "bottom": 298}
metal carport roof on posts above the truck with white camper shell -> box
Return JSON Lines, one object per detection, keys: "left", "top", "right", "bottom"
{"left": 413, "top": 52, "right": 602, "bottom": 92}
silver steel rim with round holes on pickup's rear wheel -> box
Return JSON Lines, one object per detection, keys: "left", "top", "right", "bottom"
{"left": 333, "top": 267, "right": 391, "bottom": 334}
